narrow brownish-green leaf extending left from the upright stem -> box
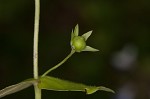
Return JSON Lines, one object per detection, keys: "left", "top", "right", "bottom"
{"left": 0, "top": 79, "right": 37, "bottom": 98}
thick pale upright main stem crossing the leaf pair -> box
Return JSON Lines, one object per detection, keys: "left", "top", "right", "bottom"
{"left": 33, "top": 0, "right": 41, "bottom": 99}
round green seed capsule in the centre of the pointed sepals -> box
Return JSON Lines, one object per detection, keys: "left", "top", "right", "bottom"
{"left": 71, "top": 36, "right": 86, "bottom": 52}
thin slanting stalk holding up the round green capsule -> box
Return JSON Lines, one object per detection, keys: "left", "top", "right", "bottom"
{"left": 42, "top": 50, "right": 75, "bottom": 77}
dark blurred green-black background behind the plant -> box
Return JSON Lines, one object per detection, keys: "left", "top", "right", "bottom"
{"left": 0, "top": 0, "right": 150, "bottom": 99}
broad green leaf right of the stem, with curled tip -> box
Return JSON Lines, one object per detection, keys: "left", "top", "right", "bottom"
{"left": 38, "top": 76, "right": 114, "bottom": 94}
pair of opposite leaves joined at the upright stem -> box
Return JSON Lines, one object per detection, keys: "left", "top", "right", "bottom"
{"left": 0, "top": 76, "right": 114, "bottom": 98}
